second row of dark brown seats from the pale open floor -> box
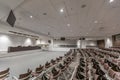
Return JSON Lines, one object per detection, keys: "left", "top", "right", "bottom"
{"left": 37, "top": 49, "right": 76, "bottom": 80}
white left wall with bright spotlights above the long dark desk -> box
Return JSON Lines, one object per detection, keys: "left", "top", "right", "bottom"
{"left": 0, "top": 21, "right": 51, "bottom": 53}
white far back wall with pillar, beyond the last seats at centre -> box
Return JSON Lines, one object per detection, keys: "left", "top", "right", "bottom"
{"left": 51, "top": 40, "right": 97, "bottom": 51}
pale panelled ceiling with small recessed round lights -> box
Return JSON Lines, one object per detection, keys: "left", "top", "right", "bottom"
{"left": 0, "top": 0, "right": 120, "bottom": 37}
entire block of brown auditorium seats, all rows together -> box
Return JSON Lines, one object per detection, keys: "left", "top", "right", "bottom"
{"left": 0, "top": 49, "right": 120, "bottom": 80}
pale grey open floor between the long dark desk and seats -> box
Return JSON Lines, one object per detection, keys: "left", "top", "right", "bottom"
{"left": 0, "top": 51, "right": 66, "bottom": 76}
